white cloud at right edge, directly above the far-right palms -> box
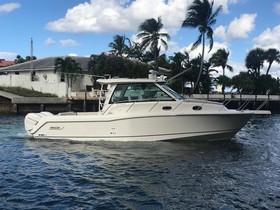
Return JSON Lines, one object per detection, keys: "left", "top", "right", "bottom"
{"left": 253, "top": 25, "right": 280, "bottom": 50}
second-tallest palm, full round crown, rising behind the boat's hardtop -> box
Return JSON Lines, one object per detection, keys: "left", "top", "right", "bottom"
{"left": 137, "top": 17, "right": 170, "bottom": 69}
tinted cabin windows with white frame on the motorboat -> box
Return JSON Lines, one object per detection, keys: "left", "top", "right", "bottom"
{"left": 109, "top": 82, "right": 177, "bottom": 104}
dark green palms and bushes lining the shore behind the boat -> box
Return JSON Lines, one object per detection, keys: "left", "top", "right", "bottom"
{"left": 2, "top": 0, "right": 280, "bottom": 98}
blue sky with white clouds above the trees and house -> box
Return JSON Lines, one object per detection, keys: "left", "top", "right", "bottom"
{"left": 0, "top": 0, "right": 280, "bottom": 78}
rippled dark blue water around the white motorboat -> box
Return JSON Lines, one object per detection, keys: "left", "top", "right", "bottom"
{"left": 0, "top": 115, "right": 280, "bottom": 210}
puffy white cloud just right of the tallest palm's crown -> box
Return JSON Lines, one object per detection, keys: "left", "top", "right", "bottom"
{"left": 214, "top": 14, "right": 257, "bottom": 41}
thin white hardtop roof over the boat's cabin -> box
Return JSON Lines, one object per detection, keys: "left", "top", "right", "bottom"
{"left": 97, "top": 78, "right": 166, "bottom": 85}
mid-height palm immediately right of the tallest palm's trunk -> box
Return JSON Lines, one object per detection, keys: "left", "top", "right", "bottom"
{"left": 209, "top": 49, "right": 233, "bottom": 94}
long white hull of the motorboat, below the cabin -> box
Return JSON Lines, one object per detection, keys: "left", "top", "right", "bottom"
{"left": 26, "top": 111, "right": 252, "bottom": 141}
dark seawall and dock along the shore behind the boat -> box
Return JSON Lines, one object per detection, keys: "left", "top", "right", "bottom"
{"left": 0, "top": 91, "right": 280, "bottom": 114}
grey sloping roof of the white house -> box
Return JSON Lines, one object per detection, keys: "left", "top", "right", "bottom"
{"left": 0, "top": 56, "right": 89, "bottom": 72}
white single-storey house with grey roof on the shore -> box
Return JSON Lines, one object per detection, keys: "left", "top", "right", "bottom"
{"left": 0, "top": 56, "right": 96, "bottom": 97}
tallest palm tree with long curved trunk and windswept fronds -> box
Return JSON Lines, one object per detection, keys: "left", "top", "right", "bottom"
{"left": 182, "top": 0, "right": 222, "bottom": 91}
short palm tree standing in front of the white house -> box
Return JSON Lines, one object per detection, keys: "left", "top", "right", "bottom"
{"left": 54, "top": 57, "right": 82, "bottom": 96}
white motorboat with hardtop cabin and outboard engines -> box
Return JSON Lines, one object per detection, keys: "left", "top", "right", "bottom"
{"left": 24, "top": 74, "right": 253, "bottom": 141}
